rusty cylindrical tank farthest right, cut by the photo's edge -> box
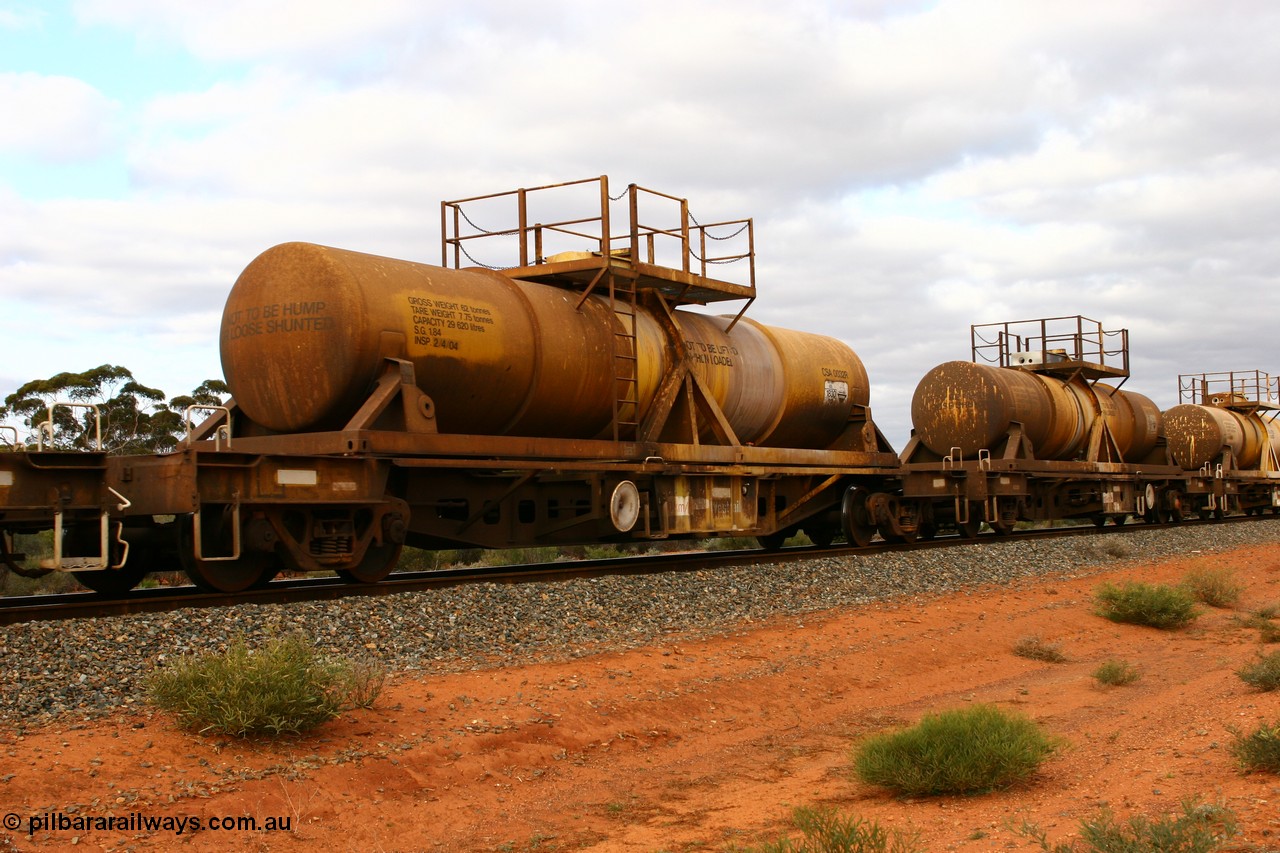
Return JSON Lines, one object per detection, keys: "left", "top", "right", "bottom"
{"left": 1165, "top": 405, "right": 1280, "bottom": 470}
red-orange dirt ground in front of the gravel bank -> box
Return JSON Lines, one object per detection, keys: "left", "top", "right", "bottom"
{"left": 0, "top": 544, "right": 1280, "bottom": 853}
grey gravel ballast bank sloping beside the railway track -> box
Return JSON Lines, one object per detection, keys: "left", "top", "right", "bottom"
{"left": 0, "top": 519, "right": 1280, "bottom": 725}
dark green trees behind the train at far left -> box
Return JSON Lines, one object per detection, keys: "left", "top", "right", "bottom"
{"left": 0, "top": 364, "right": 228, "bottom": 453}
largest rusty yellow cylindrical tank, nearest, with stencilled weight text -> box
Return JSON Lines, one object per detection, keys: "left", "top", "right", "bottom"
{"left": 220, "top": 243, "right": 869, "bottom": 448}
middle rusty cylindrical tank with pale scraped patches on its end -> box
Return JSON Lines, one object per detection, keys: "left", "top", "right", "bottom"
{"left": 911, "top": 361, "right": 1160, "bottom": 461}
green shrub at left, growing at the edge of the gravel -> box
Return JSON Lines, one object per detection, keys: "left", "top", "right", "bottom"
{"left": 147, "top": 634, "right": 387, "bottom": 736}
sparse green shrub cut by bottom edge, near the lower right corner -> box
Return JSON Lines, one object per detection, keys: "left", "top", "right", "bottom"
{"left": 1020, "top": 800, "right": 1236, "bottom": 853}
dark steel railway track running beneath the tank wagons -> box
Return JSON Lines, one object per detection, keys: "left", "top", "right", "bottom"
{"left": 0, "top": 516, "right": 1228, "bottom": 625}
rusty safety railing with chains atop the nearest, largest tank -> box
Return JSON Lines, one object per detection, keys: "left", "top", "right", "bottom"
{"left": 440, "top": 175, "right": 755, "bottom": 288}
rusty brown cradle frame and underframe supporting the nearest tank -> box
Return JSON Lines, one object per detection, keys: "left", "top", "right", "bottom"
{"left": 165, "top": 345, "right": 897, "bottom": 567}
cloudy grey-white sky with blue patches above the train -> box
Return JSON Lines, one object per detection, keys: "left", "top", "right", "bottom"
{"left": 0, "top": 0, "right": 1280, "bottom": 448}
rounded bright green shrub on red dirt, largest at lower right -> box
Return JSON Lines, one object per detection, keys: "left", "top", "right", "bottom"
{"left": 854, "top": 704, "right": 1059, "bottom": 794}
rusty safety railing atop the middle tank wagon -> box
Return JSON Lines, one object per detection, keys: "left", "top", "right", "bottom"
{"left": 969, "top": 315, "right": 1129, "bottom": 375}
